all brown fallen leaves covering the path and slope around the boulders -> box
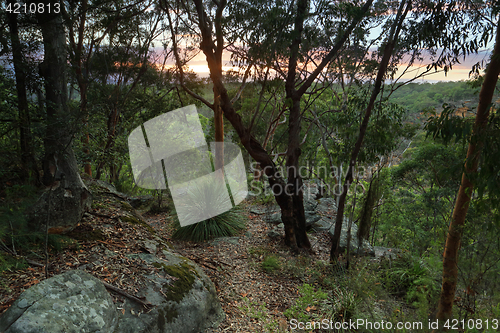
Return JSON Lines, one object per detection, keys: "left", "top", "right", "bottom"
{"left": 0, "top": 192, "right": 336, "bottom": 333}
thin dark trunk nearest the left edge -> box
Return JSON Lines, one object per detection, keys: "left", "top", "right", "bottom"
{"left": 7, "top": 0, "right": 40, "bottom": 182}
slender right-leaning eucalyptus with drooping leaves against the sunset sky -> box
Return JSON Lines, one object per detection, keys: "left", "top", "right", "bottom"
{"left": 330, "top": 1, "right": 492, "bottom": 260}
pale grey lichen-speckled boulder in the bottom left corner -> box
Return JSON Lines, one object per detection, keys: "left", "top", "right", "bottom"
{"left": 0, "top": 270, "right": 118, "bottom": 333}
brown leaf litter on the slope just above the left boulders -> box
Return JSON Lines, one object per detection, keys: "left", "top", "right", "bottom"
{"left": 0, "top": 196, "right": 168, "bottom": 314}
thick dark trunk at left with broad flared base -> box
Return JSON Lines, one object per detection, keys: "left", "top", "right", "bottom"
{"left": 30, "top": 5, "right": 91, "bottom": 232}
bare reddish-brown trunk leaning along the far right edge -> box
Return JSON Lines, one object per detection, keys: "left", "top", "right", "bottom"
{"left": 436, "top": 21, "right": 500, "bottom": 330}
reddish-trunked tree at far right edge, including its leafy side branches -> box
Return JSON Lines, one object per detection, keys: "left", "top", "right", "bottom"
{"left": 428, "top": 13, "right": 500, "bottom": 330}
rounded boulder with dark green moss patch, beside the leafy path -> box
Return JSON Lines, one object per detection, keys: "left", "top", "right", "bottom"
{"left": 117, "top": 251, "right": 224, "bottom": 333}
